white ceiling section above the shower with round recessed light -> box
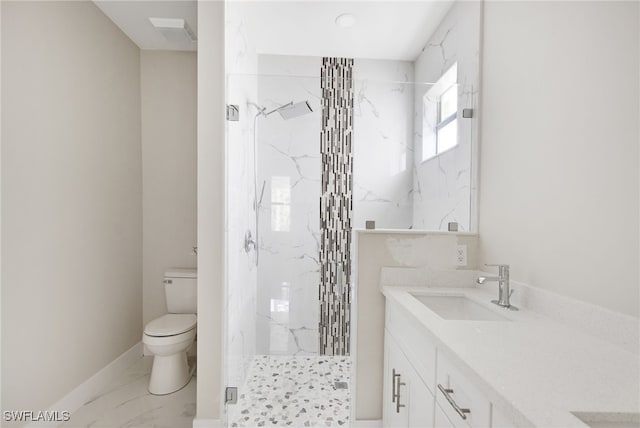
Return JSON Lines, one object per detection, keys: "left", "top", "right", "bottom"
{"left": 227, "top": 0, "right": 453, "bottom": 61}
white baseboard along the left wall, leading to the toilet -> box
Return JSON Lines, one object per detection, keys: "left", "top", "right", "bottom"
{"left": 26, "top": 342, "right": 142, "bottom": 428}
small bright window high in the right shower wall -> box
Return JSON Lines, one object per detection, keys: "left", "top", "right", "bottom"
{"left": 422, "top": 64, "right": 458, "bottom": 161}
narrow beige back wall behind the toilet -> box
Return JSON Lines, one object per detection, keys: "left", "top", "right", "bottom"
{"left": 140, "top": 51, "right": 197, "bottom": 336}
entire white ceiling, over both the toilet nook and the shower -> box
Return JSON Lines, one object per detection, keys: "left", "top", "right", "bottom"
{"left": 94, "top": 0, "right": 453, "bottom": 61}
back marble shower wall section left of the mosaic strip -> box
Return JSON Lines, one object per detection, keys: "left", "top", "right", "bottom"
{"left": 257, "top": 55, "right": 321, "bottom": 355}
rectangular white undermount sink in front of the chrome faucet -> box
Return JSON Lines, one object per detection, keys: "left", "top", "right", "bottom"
{"left": 411, "top": 293, "right": 509, "bottom": 321}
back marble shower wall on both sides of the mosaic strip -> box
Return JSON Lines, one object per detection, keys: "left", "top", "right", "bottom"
{"left": 256, "top": 55, "right": 422, "bottom": 355}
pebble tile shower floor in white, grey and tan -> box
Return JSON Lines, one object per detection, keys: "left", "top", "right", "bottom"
{"left": 228, "top": 355, "right": 351, "bottom": 428}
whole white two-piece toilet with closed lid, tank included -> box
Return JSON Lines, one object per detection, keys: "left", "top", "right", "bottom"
{"left": 142, "top": 269, "right": 197, "bottom": 395}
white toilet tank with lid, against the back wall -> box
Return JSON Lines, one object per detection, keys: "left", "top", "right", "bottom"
{"left": 164, "top": 268, "right": 198, "bottom": 314}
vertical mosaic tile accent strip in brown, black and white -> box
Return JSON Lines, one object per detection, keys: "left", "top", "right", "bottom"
{"left": 319, "top": 58, "right": 353, "bottom": 355}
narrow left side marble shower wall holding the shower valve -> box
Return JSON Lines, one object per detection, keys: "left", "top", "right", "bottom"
{"left": 225, "top": 8, "right": 258, "bottom": 385}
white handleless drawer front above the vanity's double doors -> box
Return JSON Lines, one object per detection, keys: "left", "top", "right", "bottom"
{"left": 385, "top": 300, "right": 436, "bottom": 395}
